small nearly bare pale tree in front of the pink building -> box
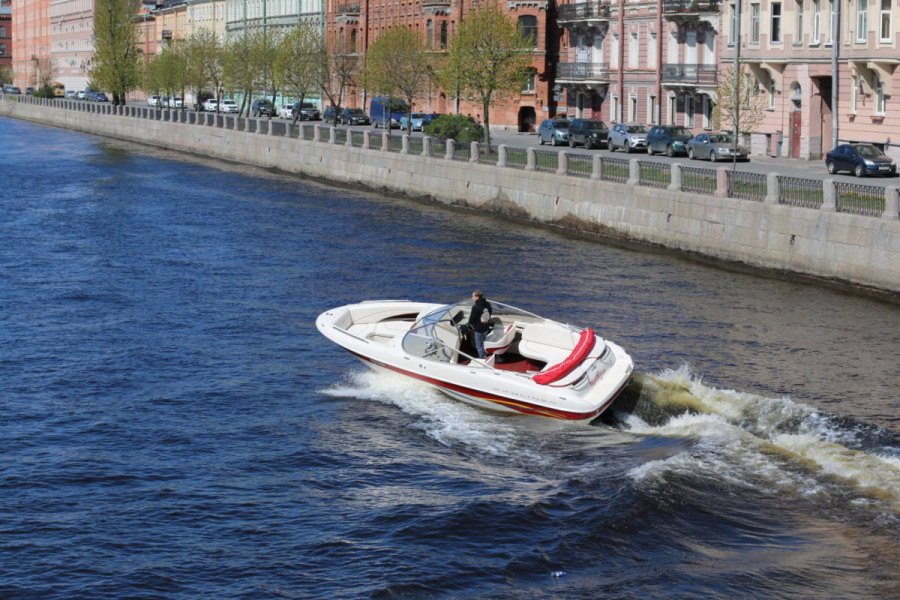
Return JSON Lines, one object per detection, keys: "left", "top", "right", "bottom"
{"left": 712, "top": 66, "right": 767, "bottom": 133}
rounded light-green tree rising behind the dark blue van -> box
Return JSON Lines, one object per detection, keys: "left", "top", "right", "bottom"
{"left": 363, "top": 25, "right": 431, "bottom": 133}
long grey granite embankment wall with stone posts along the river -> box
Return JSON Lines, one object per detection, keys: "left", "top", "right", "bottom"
{"left": 0, "top": 100, "right": 900, "bottom": 299}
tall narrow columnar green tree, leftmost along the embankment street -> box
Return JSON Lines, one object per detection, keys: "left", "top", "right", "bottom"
{"left": 90, "top": 0, "right": 141, "bottom": 104}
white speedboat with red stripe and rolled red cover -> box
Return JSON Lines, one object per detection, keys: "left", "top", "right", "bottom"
{"left": 316, "top": 299, "right": 634, "bottom": 421}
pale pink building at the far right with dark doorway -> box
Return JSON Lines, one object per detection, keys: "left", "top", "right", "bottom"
{"left": 722, "top": 0, "right": 900, "bottom": 159}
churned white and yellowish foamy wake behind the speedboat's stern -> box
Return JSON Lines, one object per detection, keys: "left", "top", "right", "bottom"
{"left": 614, "top": 367, "right": 900, "bottom": 513}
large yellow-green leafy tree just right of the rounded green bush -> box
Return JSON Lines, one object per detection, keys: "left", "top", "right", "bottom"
{"left": 441, "top": 2, "right": 533, "bottom": 144}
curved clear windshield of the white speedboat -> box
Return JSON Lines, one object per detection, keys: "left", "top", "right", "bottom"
{"left": 403, "top": 299, "right": 540, "bottom": 362}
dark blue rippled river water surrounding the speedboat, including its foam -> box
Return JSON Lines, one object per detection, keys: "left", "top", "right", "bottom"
{"left": 0, "top": 119, "right": 900, "bottom": 600}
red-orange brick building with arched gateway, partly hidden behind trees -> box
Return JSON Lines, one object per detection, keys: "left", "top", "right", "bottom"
{"left": 325, "top": 0, "right": 559, "bottom": 131}
